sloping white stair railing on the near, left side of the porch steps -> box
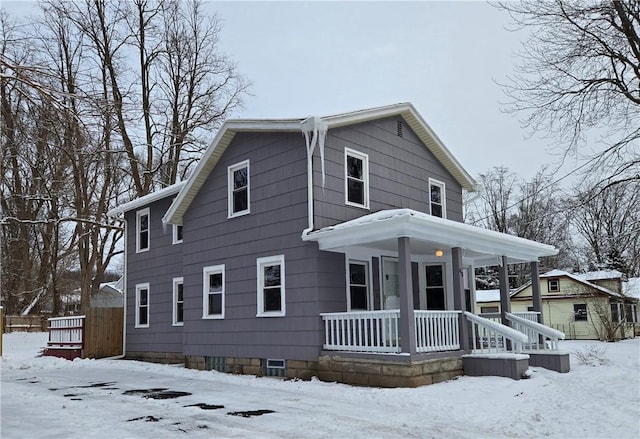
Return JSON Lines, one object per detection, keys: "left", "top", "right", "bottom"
{"left": 464, "top": 311, "right": 529, "bottom": 354}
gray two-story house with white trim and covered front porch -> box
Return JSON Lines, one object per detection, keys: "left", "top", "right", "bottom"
{"left": 110, "top": 104, "right": 556, "bottom": 385}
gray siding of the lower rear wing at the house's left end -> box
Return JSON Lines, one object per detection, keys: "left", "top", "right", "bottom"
{"left": 125, "top": 195, "right": 183, "bottom": 352}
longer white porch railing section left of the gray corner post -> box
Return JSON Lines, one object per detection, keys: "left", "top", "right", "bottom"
{"left": 320, "top": 310, "right": 400, "bottom": 352}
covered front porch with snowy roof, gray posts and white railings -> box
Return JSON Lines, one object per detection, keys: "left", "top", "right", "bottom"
{"left": 303, "top": 209, "right": 562, "bottom": 382}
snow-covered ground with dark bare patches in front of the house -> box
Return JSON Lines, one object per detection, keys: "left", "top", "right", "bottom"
{"left": 0, "top": 333, "right": 640, "bottom": 439}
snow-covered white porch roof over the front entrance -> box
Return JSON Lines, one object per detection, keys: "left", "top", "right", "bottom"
{"left": 302, "top": 209, "right": 558, "bottom": 266}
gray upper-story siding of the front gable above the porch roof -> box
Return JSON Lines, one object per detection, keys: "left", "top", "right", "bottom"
{"left": 314, "top": 117, "right": 463, "bottom": 229}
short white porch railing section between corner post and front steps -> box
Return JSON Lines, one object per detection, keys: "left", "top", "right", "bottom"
{"left": 414, "top": 311, "right": 460, "bottom": 352}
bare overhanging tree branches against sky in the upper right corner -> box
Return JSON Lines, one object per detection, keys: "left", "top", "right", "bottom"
{"left": 498, "top": 0, "right": 640, "bottom": 187}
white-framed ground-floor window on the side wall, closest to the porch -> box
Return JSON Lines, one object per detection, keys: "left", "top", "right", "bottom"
{"left": 256, "top": 255, "right": 286, "bottom": 317}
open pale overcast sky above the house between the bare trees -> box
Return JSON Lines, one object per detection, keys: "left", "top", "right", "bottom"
{"left": 2, "top": 0, "right": 573, "bottom": 182}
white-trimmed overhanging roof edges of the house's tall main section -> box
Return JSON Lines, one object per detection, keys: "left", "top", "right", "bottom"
{"left": 163, "top": 103, "right": 476, "bottom": 224}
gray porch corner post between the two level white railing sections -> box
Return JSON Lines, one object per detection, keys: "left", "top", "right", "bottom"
{"left": 398, "top": 236, "right": 417, "bottom": 355}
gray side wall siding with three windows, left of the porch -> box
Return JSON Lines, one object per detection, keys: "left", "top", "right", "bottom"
{"left": 184, "top": 133, "right": 346, "bottom": 360}
